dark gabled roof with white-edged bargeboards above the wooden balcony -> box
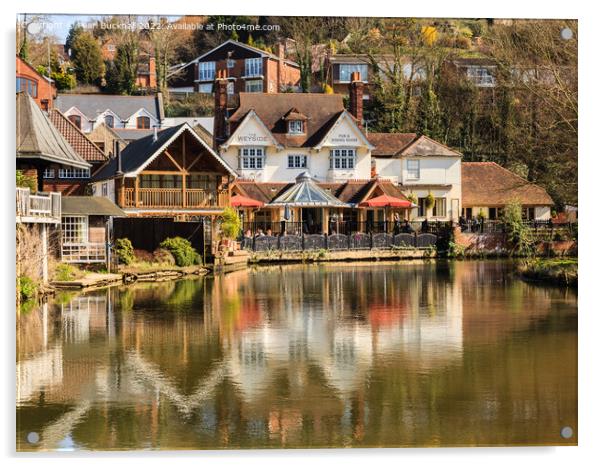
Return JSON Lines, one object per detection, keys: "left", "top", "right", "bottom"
{"left": 93, "top": 123, "right": 236, "bottom": 181}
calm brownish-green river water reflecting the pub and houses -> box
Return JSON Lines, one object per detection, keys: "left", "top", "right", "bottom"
{"left": 17, "top": 261, "right": 577, "bottom": 450}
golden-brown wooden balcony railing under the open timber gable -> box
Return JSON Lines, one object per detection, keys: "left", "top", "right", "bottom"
{"left": 120, "top": 188, "right": 229, "bottom": 209}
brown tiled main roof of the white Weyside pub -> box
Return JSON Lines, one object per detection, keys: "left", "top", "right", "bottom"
{"left": 229, "top": 92, "right": 345, "bottom": 147}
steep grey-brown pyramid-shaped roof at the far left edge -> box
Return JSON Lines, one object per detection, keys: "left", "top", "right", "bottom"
{"left": 16, "top": 92, "right": 90, "bottom": 168}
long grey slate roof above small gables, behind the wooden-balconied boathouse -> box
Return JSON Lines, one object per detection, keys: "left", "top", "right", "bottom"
{"left": 54, "top": 94, "right": 164, "bottom": 120}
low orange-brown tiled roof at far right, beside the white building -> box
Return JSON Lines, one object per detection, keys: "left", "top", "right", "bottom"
{"left": 462, "top": 162, "right": 554, "bottom": 207}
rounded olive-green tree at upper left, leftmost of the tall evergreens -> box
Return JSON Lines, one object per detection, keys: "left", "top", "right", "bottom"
{"left": 71, "top": 30, "right": 105, "bottom": 85}
